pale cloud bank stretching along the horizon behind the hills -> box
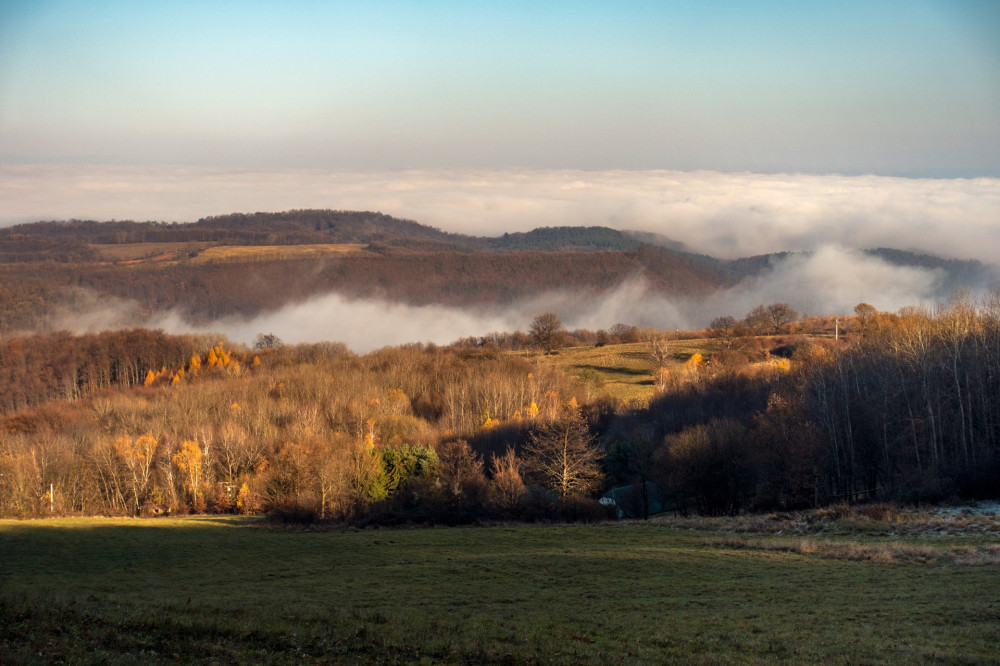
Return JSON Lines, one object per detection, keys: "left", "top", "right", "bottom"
{"left": 0, "top": 165, "right": 1000, "bottom": 262}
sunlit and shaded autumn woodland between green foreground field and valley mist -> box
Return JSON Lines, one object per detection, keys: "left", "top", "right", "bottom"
{"left": 0, "top": 295, "right": 1000, "bottom": 523}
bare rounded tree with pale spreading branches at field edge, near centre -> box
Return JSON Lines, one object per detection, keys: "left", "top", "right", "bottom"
{"left": 524, "top": 408, "right": 604, "bottom": 508}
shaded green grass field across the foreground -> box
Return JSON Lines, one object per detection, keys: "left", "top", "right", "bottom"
{"left": 0, "top": 517, "right": 1000, "bottom": 664}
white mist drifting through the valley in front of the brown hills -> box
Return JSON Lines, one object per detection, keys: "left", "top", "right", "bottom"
{"left": 48, "top": 246, "right": 960, "bottom": 353}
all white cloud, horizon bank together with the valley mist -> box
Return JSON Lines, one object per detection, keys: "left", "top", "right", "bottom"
{"left": 13, "top": 165, "right": 1000, "bottom": 351}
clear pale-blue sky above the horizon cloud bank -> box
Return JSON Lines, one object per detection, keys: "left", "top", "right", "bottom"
{"left": 0, "top": 0, "right": 1000, "bottom": 177}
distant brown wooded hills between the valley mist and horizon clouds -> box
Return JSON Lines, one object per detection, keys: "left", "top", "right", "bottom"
{"left": 0, "top": 210, "right": 1000, "bottom": 335}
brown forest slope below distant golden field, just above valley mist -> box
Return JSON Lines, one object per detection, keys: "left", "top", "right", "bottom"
{"left": 0, "top": 245, "right": 736, "bottom": 335}
